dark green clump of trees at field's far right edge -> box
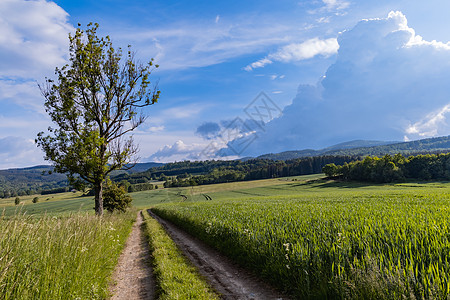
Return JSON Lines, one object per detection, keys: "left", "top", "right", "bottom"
{"left": 323, "top": 153, "right": 450, "bottom": 183}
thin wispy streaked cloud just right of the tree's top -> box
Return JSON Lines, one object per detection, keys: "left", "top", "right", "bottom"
{"left": 115, "top": 16, "right": 293, "bottom": 70}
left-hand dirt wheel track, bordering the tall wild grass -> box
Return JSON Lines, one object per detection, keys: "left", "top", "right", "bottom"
{"left": 111, "top": 212, "right": 155, "bottom": 300}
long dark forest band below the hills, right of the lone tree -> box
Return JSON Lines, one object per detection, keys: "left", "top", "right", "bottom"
{"left": 114, "top": 156, "right": 360, "bottom": 187}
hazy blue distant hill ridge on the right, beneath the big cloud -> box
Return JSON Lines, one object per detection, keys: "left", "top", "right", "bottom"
{"left": 257, "top": 136, "right": 450, "bottom": 160}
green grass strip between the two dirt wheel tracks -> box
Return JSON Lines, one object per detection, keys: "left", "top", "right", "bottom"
{"left": 143, "top": 210, "right": 219, "bottom": 299}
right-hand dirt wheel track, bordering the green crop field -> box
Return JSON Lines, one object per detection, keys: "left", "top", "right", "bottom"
{"left": 149, "top": 210, "right": 288, "bottom": 300}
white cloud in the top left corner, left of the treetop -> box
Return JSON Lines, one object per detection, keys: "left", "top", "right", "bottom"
{"left": 0, "top": 0, "right": 73, "bottom": 78}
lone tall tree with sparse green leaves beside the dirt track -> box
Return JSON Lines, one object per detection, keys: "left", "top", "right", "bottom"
{"left": 36, "top": 23, "right": 160, "bottom": 215}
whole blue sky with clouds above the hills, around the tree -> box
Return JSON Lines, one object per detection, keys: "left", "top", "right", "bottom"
{"left": 0, "top": 0, "right": 450, "bottom": 169}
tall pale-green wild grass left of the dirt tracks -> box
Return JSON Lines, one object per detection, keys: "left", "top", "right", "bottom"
{"left": 0, "top": 211, "right": 136, "bottom": 299}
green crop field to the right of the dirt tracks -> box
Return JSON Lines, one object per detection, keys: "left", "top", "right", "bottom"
{"left": 150, "top": 177, "right": 450, "bottom": 299}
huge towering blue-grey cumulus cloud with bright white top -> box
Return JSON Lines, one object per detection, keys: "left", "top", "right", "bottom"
{"left": 230, "top": 12, "right": 450, "bottom": 155}
